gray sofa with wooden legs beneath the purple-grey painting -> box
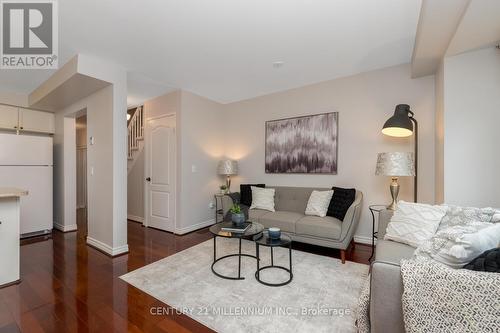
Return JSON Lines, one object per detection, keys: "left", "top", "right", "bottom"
{"left": 225, "top": 186, "right": 363, "bottom": 263}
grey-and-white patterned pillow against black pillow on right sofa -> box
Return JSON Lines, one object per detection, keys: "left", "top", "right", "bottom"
{"left": 415, "top": 222, "right": 500, "bottom": 268}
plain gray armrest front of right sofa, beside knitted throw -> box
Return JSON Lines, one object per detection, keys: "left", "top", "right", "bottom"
{"left": 370, "top": 261, "right": 405, "bottom": 333}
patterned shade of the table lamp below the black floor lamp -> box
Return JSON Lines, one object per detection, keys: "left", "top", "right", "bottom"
{"left": 375, "top": 152, "right": 415, "bottom": 177}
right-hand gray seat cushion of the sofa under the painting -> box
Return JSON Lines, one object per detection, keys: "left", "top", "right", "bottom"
{"left": 295, "top": 216, "right": 342, "bottom": 239}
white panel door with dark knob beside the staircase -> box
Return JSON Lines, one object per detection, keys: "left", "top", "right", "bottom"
{"left": 145, "top": 116, "right": 176, "bottom": 232}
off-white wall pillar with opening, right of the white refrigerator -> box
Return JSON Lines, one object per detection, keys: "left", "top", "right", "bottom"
{"left": 47, "top": 55, "right": 128, "bottom": 255}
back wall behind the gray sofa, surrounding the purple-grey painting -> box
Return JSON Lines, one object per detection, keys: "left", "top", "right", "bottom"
{"left": 222, "top": 65, "right": 435, "bottom": 240}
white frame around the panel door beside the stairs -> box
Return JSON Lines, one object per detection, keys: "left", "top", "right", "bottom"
{"left": 142, "top": 113, "right": 178, "bottom": 233}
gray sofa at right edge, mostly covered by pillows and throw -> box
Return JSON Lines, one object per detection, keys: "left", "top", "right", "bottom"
{"left": 370, "top": 210, "right": 415, "bottom": 333}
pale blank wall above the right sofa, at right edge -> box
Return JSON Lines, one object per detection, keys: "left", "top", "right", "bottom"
{"left": 443, "top": 47, "right": 500, "bottom": 207}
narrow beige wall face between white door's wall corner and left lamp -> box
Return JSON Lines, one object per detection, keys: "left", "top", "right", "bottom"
{"left": 176, "top": 91, "right": 223, "bottom": 233}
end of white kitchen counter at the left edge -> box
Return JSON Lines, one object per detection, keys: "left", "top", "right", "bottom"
{"left": 0, "top": 187, "right": 28, "bottom": 288}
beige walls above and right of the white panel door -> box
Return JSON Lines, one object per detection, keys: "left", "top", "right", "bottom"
{"left": 137, "top": 91, "right": 224, "bottom": 234}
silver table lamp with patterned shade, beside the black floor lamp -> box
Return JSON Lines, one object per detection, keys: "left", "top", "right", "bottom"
{"left": 375, "top": 152, "right": 415, "bottom": 210}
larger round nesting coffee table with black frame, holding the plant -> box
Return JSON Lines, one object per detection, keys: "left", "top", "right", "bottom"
{"left": 209, "top": 221, "right": 264, "bottom": 280}
